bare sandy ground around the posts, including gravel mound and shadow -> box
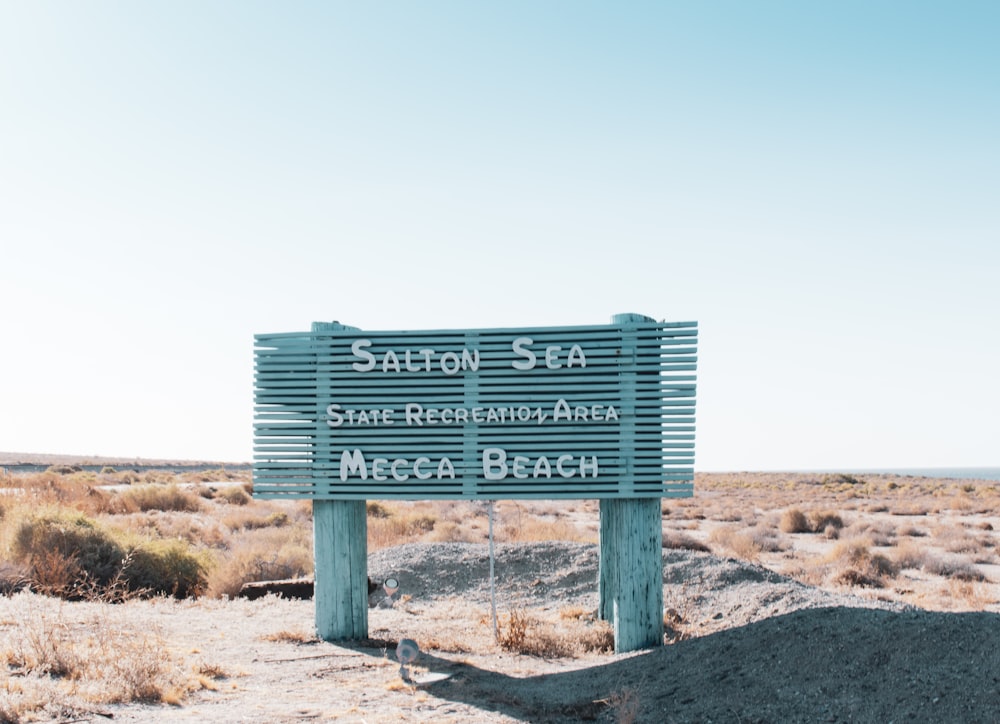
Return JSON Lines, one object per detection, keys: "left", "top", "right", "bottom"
{"left": 9, "top": 543, "right": 1000, "bottom": 723}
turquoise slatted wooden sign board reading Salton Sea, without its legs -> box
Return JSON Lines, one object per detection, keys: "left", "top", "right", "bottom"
{"left": 254, "top": 322, "right": 697, "bottom": 500}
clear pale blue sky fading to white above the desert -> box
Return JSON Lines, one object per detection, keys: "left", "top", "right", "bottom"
{"left": 0, "top": 0, "right": 1000, "bottom": 471}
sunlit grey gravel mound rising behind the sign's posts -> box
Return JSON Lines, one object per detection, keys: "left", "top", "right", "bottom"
{"left": 368, "top": 541, "right": 903, "bottom": 633}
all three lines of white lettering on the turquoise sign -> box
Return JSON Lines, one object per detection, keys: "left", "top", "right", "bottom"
{"left": 326, "top": 336, "right": 604, "bottom": 482}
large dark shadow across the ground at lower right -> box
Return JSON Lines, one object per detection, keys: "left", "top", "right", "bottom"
{"left": 342, "top": 607, "right": 1000, "bottom": 724}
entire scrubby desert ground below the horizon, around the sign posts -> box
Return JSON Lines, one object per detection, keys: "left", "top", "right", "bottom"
{"left": 0, "top": 460, "right": 1000, "bottom": 722}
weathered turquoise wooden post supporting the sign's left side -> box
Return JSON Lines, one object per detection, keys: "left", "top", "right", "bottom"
{"left": 312, "top": 322, "right": 368, "bottom": 641}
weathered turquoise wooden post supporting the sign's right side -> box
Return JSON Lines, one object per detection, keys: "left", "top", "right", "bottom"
{"left": 598, "top": 314, "right": 663, "bottom": 653}
